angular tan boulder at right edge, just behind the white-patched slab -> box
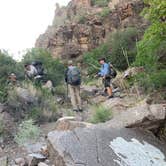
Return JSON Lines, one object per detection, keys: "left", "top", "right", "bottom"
{"left": 107, "top": 101, "right": 166, "bottom": 129}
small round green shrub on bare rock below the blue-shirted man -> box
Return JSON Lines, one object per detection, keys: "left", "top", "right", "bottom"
{"left": 90, "top": 106, "right": 112, "bottom": 124}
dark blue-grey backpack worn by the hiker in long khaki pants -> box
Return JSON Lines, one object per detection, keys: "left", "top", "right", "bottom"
{"left": 67, "top": 67, "right": 81, "bottom": 85}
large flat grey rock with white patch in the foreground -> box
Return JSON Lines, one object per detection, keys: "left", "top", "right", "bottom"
{"left": 48, "top": 125, "right": 166, "bottom": 166}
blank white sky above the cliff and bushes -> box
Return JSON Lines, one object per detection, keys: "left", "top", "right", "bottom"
{"left": 0, "top": 0, "right": 70, "bottom": 59}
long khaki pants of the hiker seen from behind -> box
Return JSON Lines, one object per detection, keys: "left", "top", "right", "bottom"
{"left": 69, "top": 85, "right": 82, "bottom": 110}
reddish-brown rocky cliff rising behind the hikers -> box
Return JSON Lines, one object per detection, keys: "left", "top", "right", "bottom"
{"left": 35, "top": 0, "right": 146, "bottom": 59}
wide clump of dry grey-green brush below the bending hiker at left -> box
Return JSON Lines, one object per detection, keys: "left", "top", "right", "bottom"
{"left": 7, "top": 83, "right": 60, "bottom": 123}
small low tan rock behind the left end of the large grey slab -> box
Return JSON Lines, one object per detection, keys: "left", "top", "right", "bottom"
{"left": 55, "top": 117, "right": 92, "bottom": 131}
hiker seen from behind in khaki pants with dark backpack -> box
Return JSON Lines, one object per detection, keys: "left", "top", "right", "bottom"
{"left": 65, "top": 61, "right": 83, "bottom": 112}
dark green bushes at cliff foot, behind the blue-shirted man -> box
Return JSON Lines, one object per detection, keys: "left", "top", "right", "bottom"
{"left": 84, "top": 28, "right": 138, "bottom": 75}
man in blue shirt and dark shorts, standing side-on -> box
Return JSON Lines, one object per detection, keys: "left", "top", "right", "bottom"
{"left": 98, "top": 58, "right": 113, "bottom": 99}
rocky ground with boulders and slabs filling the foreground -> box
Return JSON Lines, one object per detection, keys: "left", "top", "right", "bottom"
{"left": 0, "top": 82, "right": 166, "bottom": 166}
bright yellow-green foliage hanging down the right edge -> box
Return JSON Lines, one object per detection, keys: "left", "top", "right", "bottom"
{"left": 134, "top": 0, "right": 166, "bottom": 90}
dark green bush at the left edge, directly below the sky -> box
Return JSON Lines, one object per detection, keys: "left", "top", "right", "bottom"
{"left": 0, "top": 52, "right": 24, "bottom": 102}
